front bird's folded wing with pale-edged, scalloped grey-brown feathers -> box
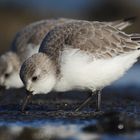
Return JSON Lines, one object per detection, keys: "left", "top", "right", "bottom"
{"left": 71, "top": 22, "right": 140, "bottom": 58}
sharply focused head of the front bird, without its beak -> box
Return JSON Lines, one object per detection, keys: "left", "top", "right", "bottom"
{"left": 20, "top": 53, "right": 56, "bottom": 94}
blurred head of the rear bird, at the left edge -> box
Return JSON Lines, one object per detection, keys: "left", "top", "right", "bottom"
{"left": 0, "top": 52, "right": 23, "bottom": 89}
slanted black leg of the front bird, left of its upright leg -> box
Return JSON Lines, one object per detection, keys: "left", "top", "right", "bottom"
{"left": 75, "top": 91, "right": 97, "bottom": 112}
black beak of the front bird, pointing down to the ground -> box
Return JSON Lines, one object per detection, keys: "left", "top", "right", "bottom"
{"left": 21, "top": 90, "right": 33, "bottom": 112}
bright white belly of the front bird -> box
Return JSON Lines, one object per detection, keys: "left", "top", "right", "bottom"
{"left": 55, "top": 49, "right": 140, "bottom": 91}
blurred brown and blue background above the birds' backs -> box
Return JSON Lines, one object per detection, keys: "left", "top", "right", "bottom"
{"left": 0, "top": 0, "right": 140, "bottom": 53}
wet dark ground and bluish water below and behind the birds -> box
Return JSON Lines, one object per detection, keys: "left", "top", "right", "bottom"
{"left": 0, "top": 67, "right": 140, "bottom": 140}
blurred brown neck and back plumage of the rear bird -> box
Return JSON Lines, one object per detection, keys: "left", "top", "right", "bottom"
{"left": 11, "top": 18, "right": 74, "bottom": 62}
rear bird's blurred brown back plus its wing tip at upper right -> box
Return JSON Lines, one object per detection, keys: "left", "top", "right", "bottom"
{"left": 11, "top": 17, "right": 135, "bottom": 53}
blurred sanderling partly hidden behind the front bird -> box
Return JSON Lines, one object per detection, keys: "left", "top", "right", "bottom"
{"left": 0, "top": 18, "right": 76, "bottom": 89}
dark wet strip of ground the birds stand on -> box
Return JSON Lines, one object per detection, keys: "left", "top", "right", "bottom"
{"left": 0, "top": 87, "right": 140, "bottom": 121}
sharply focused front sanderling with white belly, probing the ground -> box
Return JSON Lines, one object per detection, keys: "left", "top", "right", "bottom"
{"left": 20, "top": 20, "right": 140, "bottom": 112}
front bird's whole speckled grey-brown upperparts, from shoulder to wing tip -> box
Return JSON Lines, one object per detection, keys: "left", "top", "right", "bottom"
{"left": 39, "top": 21, "right": 140, "bottom": 59}
